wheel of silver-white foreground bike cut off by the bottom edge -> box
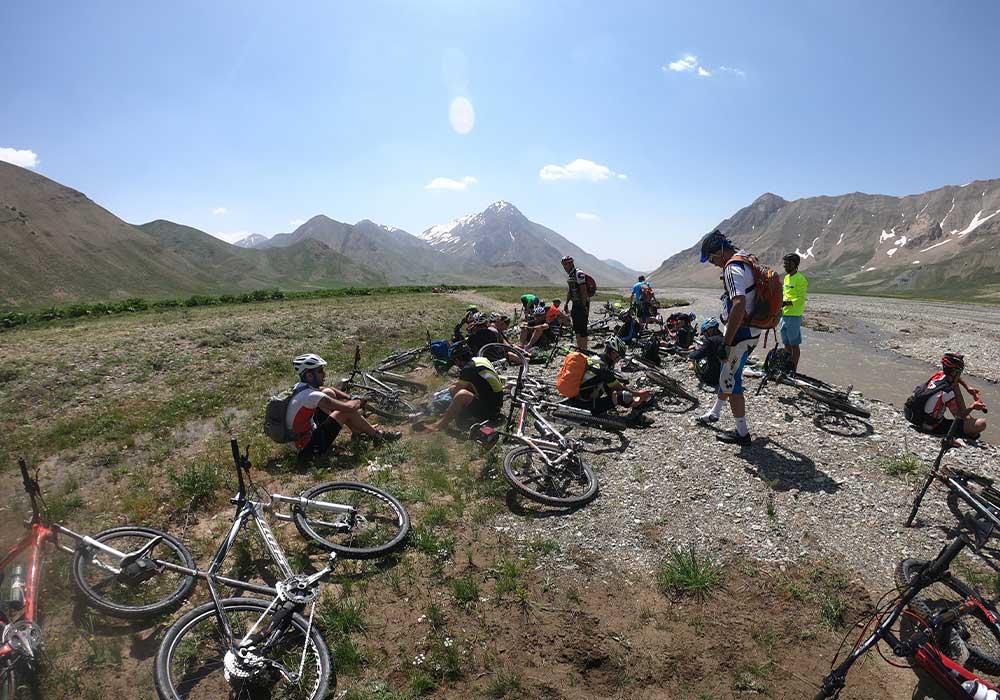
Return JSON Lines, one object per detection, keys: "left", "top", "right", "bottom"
{"left": 153, "top": 598, "right": 336, "bottom": 700}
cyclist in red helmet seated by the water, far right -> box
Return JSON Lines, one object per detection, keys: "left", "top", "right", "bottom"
{"left": 905, "top": 352, "right": 986, "bottom": 440}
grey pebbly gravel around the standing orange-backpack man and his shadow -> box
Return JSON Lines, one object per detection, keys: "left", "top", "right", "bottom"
{"left": 478, "top": 297, "right": 997, "bottom": 591}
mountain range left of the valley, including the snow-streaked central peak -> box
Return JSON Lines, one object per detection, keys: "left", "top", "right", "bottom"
{"left": 0, "top": 162, "right": 637, "bottom": 307}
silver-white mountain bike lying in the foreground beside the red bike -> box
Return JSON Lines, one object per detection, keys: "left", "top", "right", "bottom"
{"left": 154, "top": 439, "right": 410, "bottom": 700}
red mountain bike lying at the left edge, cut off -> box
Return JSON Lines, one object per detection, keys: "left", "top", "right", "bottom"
{"left": 0, "top": 457, "right": 194, "bottom": 700}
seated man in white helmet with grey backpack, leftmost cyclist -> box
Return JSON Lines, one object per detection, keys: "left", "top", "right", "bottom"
{"left": 285, "top": 353, "right": 403, "bottom": 456}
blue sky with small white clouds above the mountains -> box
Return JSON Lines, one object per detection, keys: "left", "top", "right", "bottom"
{"left": 0, "top": 0, "right": 1000, "bottom": 270}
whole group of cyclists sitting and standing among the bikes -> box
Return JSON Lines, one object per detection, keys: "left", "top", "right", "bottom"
{"left": 278, "top": 238, "right": 986, "bottom": 455}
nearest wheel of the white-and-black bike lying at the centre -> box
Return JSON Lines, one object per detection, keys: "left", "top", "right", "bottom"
{"left": 503, "top": 445, "right": 598, "bottom": 507}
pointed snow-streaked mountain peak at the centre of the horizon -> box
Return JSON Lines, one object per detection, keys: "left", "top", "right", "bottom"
{"left": 420, "top": 201, "right": 638, "bottom": 287}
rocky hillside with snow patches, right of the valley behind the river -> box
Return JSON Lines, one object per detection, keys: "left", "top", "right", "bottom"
{"left": 650, "top": 180, "right": 1000, "bottom": 300}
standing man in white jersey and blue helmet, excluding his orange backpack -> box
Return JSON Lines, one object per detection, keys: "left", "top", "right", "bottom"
{"left": 697, "top": 229, "right": 760, "bottom": 447}
